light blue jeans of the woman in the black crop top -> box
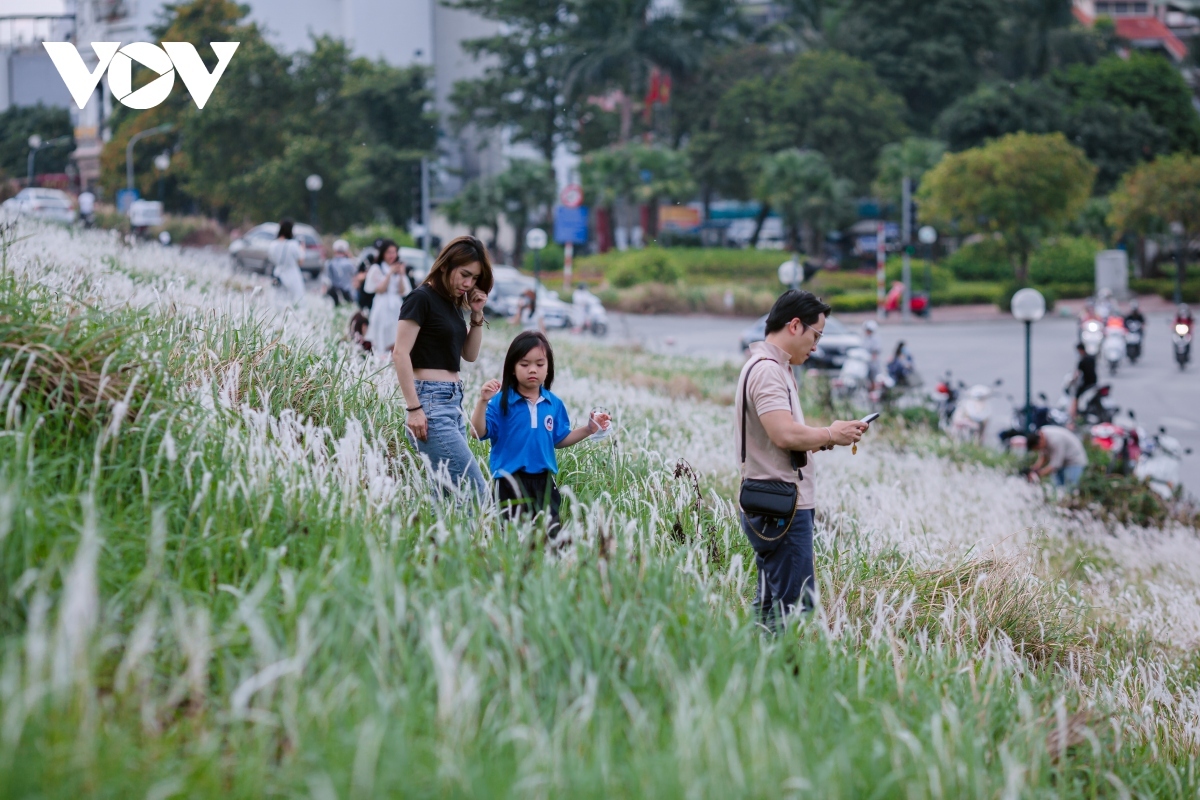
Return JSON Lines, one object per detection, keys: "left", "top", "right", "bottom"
{"left": 404, "top": 380, "right": 488, "bottom": 501}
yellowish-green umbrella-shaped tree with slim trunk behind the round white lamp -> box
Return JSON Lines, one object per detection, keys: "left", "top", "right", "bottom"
{"left": 918, "top": 133, "right": 1096, "bottom": 283}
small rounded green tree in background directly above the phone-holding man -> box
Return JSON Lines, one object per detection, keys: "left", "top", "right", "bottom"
{"left": 758, "top": 148, "right": 853, "bottom": 254}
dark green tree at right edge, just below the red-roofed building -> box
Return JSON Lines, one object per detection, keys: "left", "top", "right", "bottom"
{"left": 1057, "top": 52, "right": 1200, "bottom": 152}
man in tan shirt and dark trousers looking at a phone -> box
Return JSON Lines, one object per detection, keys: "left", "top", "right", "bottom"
{"left": 734, "top": 289, "right": 868, "bottom": 630}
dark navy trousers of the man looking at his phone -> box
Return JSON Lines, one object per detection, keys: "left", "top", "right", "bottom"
{"left": 742, "top": 509, "right": 816, "bottom": 631}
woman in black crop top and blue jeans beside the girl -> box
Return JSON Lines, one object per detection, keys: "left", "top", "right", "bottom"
{"left": 391, "top": 236, "right": 492, "bottom": 500}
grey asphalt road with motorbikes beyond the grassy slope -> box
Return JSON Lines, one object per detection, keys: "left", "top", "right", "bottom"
{"left": 608, "top": 313, "right": 1200, "bottom": 495}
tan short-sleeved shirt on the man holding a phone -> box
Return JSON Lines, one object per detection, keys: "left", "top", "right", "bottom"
{"left": 733, "top": 342, "right": 816, "bottom": 509}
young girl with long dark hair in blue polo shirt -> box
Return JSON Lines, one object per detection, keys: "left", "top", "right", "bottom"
{"left": 470, "top": 331, "right": 608, "bottom": 536}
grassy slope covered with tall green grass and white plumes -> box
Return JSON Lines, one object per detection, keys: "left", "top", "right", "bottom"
{"left": 0, "top": 221, "right": 1200, "bottom": 798}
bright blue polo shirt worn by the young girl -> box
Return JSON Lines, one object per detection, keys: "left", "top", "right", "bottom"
{"left": 484, "top": 389, "right": 571, "bottom": 477}
